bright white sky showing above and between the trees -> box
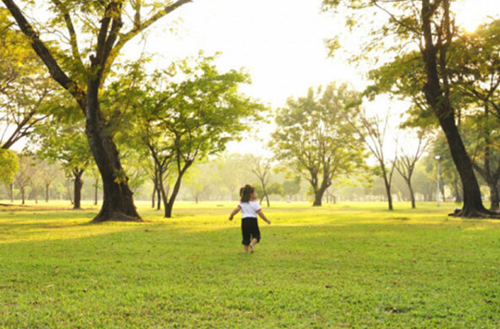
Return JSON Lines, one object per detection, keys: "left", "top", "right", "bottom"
{"left": 133, "top": 0, "right": 500, "bottom": 153}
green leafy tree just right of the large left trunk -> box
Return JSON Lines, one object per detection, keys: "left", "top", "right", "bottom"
{"left": 136, "top": 56, "right": 264, "bottom": 218}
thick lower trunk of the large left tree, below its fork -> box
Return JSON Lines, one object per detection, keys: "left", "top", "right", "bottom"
{"left": 85, "top": 76, "right": 142, "bottom": 222}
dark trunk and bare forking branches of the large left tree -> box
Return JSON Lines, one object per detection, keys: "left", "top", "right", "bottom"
{"left": 2, "top": 0, "right": 191, "bottom": 222}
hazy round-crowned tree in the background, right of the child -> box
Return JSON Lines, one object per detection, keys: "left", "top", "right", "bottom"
{"left": 269, "top": 84, "right": 365, "bottom": 206}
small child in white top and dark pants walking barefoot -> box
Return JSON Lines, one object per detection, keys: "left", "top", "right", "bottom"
{"left": 229, "top": 185, "right": 271, "bottom": 253}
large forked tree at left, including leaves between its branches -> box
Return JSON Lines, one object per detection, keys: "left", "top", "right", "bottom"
{"left": 2, "top": 0, "right": 191, "bottom": 222}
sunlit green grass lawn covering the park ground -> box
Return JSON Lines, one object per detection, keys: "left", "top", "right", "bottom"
{"left": 0, "top": 203, "right": 500, "bottom": 329}
